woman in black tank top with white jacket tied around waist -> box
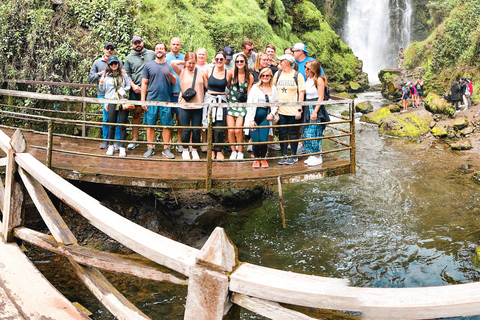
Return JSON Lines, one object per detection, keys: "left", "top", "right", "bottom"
{"left": 203, "top": 51, "right": 227, "bottom": 160}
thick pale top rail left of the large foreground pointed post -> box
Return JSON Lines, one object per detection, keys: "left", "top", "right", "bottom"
{"left": 16, "top": 153, "right": 199, "bottom": 276}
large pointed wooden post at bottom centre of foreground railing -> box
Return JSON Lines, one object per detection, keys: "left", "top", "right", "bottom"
{"left": 184, "top": 227, "right": 237, "bottom": 320}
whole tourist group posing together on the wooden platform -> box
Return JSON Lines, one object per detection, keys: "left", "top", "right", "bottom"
{"left": 89, "top": 36, "right": 330, "bottom": 168}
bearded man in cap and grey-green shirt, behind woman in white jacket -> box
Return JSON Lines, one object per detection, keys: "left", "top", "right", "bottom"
{"left": 125, "top": 36, "right": 155, "bottom": 150}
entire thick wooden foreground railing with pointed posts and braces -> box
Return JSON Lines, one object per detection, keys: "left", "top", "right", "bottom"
{"left": 0, "top": 130, "right": 480, "bottom": 320}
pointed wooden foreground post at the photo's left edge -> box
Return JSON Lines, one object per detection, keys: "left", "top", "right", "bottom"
{"left": 2, "top": 129, "right": 25, "bottom": 242}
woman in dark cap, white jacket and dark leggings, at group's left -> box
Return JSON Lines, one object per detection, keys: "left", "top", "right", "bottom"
{"left": 99, "top": 56, "right": 130, "bottom": 157}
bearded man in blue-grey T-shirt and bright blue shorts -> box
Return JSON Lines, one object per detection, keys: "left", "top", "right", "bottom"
{"left": 141, "top": 42, "right": 177, "bottom": 159}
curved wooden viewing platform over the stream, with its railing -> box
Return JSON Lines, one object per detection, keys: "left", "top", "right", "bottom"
{"left": 0, "top": 81, "right": 355, "bottom": 190}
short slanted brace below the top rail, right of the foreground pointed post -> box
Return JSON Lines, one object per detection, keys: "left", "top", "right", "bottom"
{"left": 230, "top": 293, "right": 315, "bottom": 320}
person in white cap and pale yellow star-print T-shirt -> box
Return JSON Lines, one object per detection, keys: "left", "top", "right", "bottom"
{"left": 273, "top": 54, "right": 305, "bottom": 165}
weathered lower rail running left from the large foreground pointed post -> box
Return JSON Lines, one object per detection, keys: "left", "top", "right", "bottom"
{"left": 14, "top": 228, "right": 188, "bottom": 285}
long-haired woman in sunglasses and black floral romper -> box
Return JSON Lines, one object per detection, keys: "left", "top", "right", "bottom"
{"left": 227, "top": 53, "right": 253, "bottom": 160}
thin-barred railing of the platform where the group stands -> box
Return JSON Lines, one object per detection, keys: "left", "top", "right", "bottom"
{"left": 0, "top": 81, "right": 355, "bottom": 191}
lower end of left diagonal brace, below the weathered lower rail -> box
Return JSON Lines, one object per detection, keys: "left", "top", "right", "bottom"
{"left": 68, "top": 258, "right": 150, "bottom": 320}
